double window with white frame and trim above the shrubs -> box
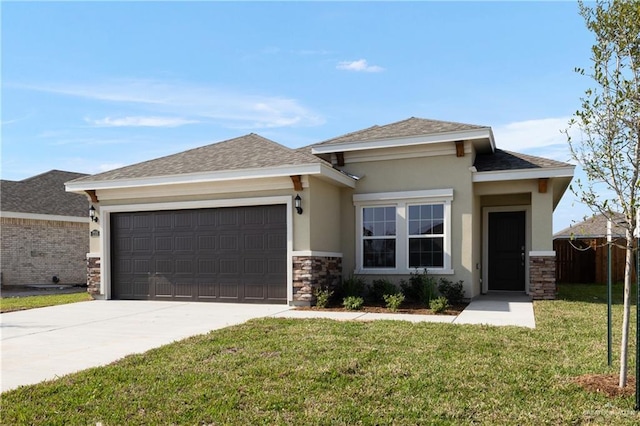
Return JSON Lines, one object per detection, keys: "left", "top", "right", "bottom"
{"left": 353, "top": 189, "right": 453, "bottom": 274}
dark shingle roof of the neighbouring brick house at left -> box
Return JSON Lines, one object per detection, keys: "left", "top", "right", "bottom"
{"left": 0, "top": 170, "right": 89, "bottom": 217}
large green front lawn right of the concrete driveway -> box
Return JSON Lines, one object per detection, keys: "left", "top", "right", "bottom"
{"left": 0, "top": 286, "right": 640, "bottom": 426}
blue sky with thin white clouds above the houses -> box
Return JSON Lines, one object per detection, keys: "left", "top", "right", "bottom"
{"left": 0, "top": 1, "right": 593, "bottom": 231}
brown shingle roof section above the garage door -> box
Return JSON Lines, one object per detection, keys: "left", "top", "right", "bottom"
{"left": 70, "top": 133, "right": 325, "bottom": 182}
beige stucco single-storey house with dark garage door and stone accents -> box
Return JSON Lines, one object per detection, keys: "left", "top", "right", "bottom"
{"left": 67, "top": 117, "right": 574, "bottom": 305}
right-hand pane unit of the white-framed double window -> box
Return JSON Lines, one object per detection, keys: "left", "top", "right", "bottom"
{"left": 408, "top": 204, "right": 444, "bottom": 268}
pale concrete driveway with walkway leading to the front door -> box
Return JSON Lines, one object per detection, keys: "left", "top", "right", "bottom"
{"left": 0, "top": 295, "right": 535, "bottom": 392}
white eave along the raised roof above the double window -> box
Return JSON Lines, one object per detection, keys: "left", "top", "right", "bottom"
{"left": 311, "top": 127, "right": 496, "bottom": 154}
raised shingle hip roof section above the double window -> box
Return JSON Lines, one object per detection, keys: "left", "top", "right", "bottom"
{"left": 315, "top": 117, "right": 489, "bottom": 145}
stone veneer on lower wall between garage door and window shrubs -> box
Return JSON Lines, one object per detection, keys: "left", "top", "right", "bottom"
{"left": 293, "top": 256, "right": 342, "bottom": 306}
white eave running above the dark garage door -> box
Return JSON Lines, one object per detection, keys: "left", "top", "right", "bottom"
{"left": 65, "top": 163, "right": 355, "bottom": 193}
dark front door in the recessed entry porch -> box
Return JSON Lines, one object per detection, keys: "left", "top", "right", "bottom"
{"left": 488, "top": 211, "right": 526, "bottom": 291}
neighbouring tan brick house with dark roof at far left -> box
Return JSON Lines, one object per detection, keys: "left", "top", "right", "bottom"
{"left": 0, "top": 170, "right": 89, "bottom": 286}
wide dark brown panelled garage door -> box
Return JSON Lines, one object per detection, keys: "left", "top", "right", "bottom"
{"left": 111, "top": 205, "right": 287, "bottom": 303}
